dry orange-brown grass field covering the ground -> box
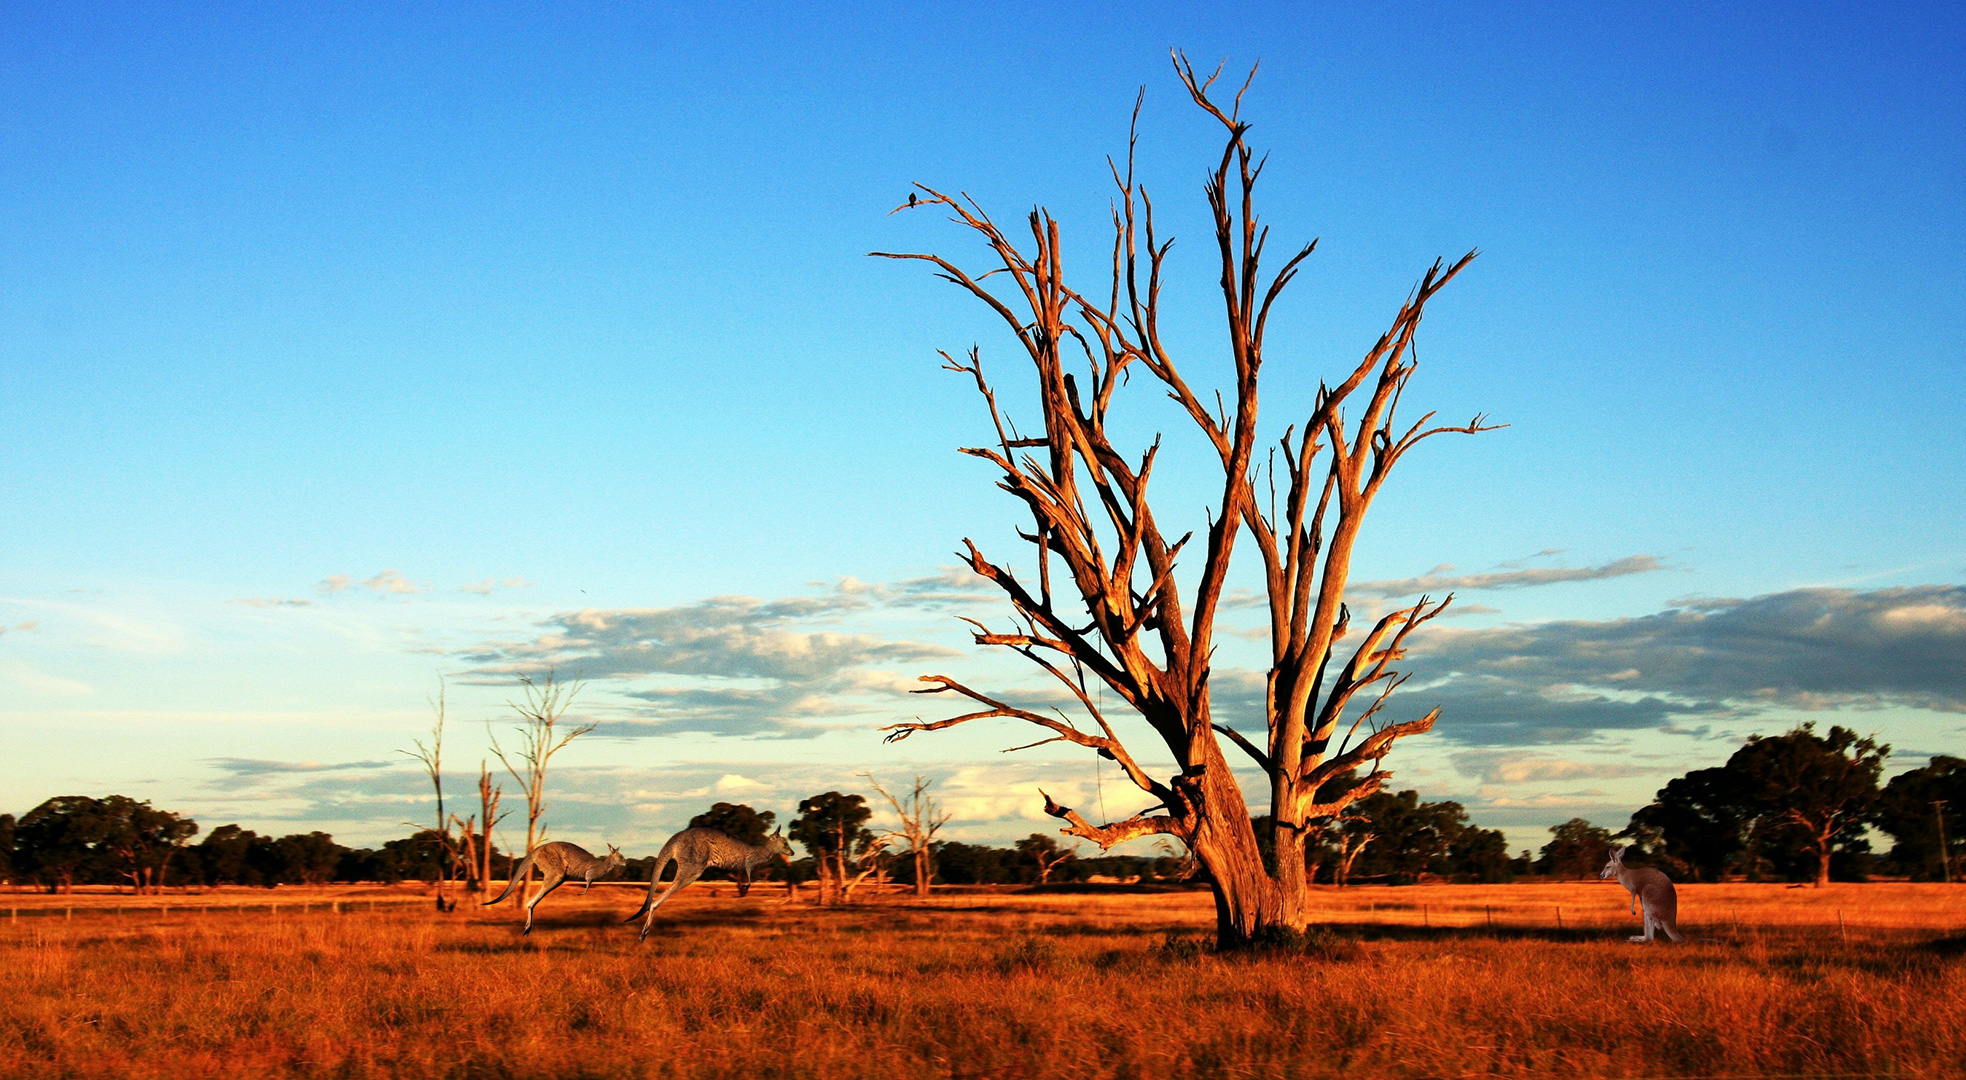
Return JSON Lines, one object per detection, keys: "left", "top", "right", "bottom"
{"left": 0, "top": 883, "right": 1966, "bottom": 1078}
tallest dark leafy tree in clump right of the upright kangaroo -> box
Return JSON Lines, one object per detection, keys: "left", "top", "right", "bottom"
{"left": 1726, "top": 724, "right": 1891, "bottom": 887}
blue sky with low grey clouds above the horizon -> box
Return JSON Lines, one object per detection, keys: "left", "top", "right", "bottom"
{"left": 0, "top": 4, "right": 1966, "bottom": 846}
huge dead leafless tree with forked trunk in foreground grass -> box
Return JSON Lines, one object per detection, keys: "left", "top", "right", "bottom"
{"left": 873, "top": 53, "right": 1490, "bottom": 946}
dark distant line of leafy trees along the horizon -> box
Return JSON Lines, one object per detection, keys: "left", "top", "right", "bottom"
{"left": 11, "top": 724, "right": 1966, "bottom": 903}
